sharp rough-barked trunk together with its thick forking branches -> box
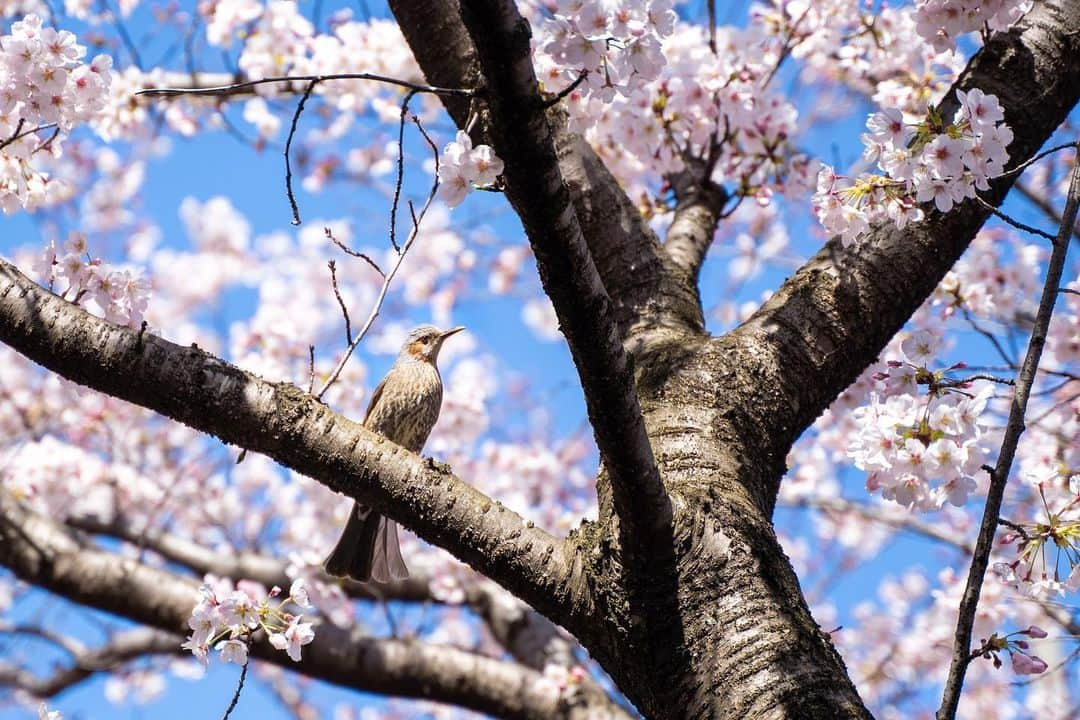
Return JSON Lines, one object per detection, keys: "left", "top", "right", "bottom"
{"left": 0, "top": 0, "right": 1080, "bottom": 719}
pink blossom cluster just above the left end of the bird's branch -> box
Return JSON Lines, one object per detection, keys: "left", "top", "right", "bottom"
{"left": 35, "top": 232, "right": 150, "bottom": 327}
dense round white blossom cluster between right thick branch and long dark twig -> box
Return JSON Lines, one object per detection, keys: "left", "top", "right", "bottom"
{"left": 848, "top": 331, "right": 989, "bottom": 510}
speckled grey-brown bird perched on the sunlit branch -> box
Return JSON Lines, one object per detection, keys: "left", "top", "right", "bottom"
{"left": 323, "top": 325, "right": 464, "bottom": 583}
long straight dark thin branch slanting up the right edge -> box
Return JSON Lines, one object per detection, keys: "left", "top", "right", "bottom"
{"left": 937, "top": 144, "right": 1080, "bottom": 720}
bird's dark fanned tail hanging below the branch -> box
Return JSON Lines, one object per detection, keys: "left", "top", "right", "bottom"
{"left": 323, "top": 503, "right": 408, "bottom": 583}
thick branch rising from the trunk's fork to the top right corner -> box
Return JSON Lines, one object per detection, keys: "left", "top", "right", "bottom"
{"left": 717, "top": 0, "right": 1080, "bottom": 498}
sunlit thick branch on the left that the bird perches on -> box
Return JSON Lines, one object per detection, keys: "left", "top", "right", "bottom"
{"left": 0, "top": 260, "right": 586, "bottom": 630}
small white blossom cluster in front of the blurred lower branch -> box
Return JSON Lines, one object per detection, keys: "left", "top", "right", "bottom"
{"left": 181, "top": 579, "right": 315, "bottom": 665}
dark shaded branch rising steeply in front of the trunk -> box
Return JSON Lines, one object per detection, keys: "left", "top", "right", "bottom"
{"left": 462, "top": 0, "right": 672, "bottom": 558}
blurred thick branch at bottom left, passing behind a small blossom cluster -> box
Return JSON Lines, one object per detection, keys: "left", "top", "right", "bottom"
{"left": 0, "top": 500, "right": 626, "bottom": 720}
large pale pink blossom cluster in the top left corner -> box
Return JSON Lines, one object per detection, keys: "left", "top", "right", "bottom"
{"left": 0, "top": 14, "right": 112, "bottom": 215}
